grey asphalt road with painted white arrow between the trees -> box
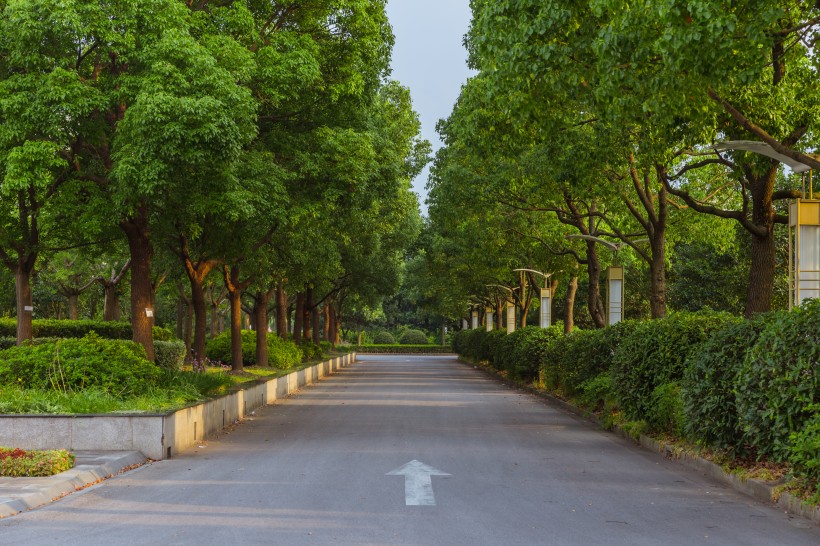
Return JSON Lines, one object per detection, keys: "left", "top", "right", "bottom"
{"left": 0, "top": 356, "right": 820, "bottom": 546}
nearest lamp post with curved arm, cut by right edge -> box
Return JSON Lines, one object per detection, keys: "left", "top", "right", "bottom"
{"left": 712, "top": 140, "right": 820, "bottom": 309}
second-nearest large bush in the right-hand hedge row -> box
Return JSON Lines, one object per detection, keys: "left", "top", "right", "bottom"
{"left": 681, "top": 315, "right": 768, "bottom": 454}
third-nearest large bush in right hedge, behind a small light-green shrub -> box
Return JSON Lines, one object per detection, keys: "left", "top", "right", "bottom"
{"left": 612, "top": 311, "right": 737, "bottom": 420}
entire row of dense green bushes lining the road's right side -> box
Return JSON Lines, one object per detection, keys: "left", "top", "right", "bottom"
{"left": 453, "top": 300, "right": 820, "bottom": 487}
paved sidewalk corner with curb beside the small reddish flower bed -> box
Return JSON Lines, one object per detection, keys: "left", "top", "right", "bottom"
{"left": 0, "top": 451, "right": 148, "bottom": 518}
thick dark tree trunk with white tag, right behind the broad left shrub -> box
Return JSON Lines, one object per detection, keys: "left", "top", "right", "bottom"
{"left": 120, "top": 211, "right": 154, "bottom": 362}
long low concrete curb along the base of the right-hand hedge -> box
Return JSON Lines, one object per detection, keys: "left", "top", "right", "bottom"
{"left": 458, "top": 358, "right": 820, "bottom": 525}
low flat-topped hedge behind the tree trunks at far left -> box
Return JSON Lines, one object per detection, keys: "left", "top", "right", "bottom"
{"left": 0, "top": 317, "right": 174, "bottom": 341}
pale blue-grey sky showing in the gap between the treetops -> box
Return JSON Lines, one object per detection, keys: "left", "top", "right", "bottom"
{"left": 387, "top": 0, "right": 472, "bottom": 215}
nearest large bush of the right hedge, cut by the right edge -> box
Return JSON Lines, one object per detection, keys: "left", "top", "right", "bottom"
{"left": 736, "top": 300, "right": 820, "bottom": 461}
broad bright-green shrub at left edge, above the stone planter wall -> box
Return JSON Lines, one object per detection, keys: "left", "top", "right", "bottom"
{"left": 0, "top": 333, "right": 160, "bottom": 395}
